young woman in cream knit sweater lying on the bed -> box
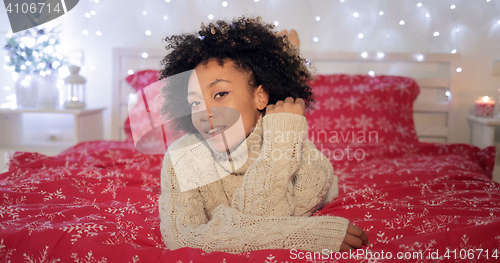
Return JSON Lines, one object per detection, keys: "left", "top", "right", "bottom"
{"left": 159, "top": 15, "right": 368, "bottom": 253}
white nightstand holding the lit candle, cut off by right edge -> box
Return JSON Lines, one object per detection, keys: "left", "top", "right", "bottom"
{"left": 467, "top": 115, "right": 500, "bottom": 182}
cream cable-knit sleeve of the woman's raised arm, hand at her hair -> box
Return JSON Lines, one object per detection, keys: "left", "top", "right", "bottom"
{"left": 233, "top": 113, "right": 338, "bottom": 216}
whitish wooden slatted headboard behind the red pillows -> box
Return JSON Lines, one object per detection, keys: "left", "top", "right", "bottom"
{"left": 112, "top": 48, "right": 459, "bottom": 142}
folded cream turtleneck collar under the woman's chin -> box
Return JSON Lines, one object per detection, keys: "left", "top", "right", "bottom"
{"left": 212, "top": 114, "right": 263, "bottom": 175}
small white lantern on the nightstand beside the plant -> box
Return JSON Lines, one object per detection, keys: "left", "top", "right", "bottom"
{"left": 64, "top": 66, "right": 87, "bottom": 109}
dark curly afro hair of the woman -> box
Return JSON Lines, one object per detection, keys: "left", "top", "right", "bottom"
{"left": 160, "top": 17, "right": 314, "bottom": 133}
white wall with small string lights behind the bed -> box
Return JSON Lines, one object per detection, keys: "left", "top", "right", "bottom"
{"left": 0, "top": 0, "right": 500, "bottom": 143}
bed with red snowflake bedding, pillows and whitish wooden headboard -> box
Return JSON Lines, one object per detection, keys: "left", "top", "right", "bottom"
{"left": 0, "top": 49, "right": 500, "bottom": 263}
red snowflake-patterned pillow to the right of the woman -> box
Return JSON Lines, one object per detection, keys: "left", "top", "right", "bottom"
{"left": 306, "top": 74, "right": 420, "bottom": 143}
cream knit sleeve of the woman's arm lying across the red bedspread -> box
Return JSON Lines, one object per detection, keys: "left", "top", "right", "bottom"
{"left": 159, "top": 153, "right": 349, "bottom": 253}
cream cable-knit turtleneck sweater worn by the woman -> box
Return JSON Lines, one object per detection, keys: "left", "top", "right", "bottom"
{"left": 159, "top": 113, "right": 349, "bottom": 253}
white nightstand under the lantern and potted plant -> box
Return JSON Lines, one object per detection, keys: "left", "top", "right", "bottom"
{"left": 0, "top": 108, "right": 105, "bottom": 153}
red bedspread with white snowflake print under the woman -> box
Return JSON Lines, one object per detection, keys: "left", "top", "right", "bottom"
{"left": 0, "top": 141, "right": 500, "bottom": 263}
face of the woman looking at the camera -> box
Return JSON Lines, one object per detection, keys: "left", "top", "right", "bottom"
{"left": 187, "top": 59, "right": 268, "bottom": 152}
